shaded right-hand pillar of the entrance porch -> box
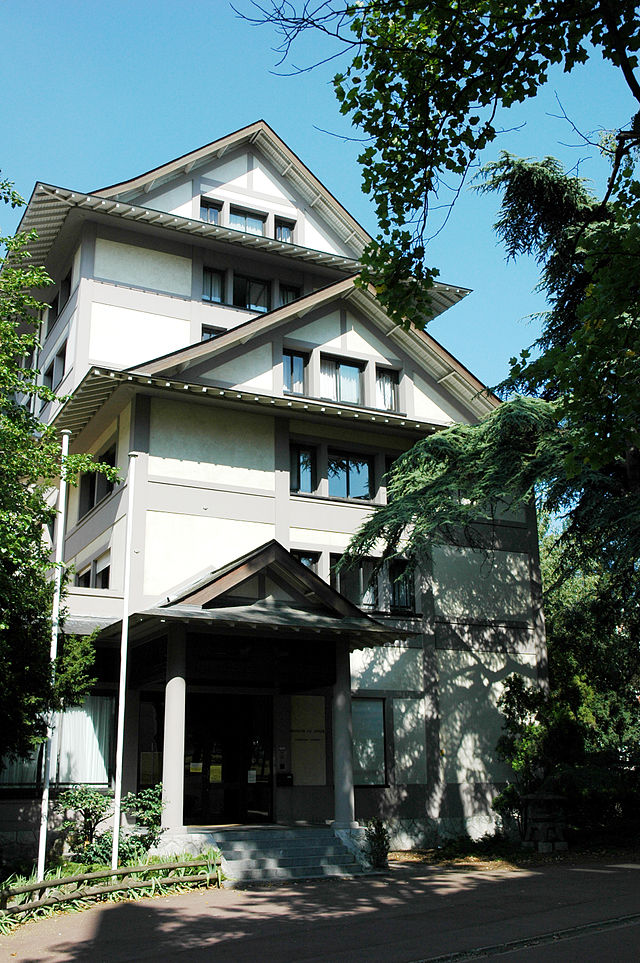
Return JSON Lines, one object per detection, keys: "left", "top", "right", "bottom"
{"left": 333, "top": 642, "right": 358, "bottom": 829}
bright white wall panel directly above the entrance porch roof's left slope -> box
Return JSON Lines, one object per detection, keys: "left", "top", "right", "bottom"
{"left": 144, "top": 511, "right": 274, "bottom": 596}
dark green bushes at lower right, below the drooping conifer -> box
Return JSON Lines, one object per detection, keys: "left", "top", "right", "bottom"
{"left": 494, "top": 533, "right": 640, "bottom": 833}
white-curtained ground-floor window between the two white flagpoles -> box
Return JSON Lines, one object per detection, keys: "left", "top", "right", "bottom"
{"left": 57, "top": 696, "right": 113, "bottom": 785}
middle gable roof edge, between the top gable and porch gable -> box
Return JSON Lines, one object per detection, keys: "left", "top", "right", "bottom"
{"left": 132, "top": 277, "right": 499, "bottom": 417}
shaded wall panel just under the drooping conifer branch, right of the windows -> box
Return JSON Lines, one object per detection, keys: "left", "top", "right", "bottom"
{"left": 433, "top": 545, "right": 532, "bottom": 621}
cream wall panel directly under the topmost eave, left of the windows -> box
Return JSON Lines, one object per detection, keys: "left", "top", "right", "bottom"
{"left": 94, "top": 237, "right": 191, "bottom": 297}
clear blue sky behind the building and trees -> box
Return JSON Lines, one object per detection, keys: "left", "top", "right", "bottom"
{"left": 0, "top": 0, "right": 637, "bottom": 384}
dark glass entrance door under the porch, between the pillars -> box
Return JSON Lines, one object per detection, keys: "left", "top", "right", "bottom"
{"left": 184, "top": 694, "right": 273, "bottom": 826}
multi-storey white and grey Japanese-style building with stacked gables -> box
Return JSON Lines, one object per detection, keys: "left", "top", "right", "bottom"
{"left": 0, "top": 121, "right": 545, "bottom": 860}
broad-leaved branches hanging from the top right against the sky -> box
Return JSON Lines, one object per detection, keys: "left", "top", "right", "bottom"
{"left": 254, "top": 0, "right": 640, "bottom": 326}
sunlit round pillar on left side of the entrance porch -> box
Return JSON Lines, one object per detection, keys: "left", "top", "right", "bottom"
{"left": 162, "top": 626, "right": 187, "bottom": 830}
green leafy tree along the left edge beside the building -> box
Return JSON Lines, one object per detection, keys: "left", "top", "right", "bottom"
{"left": 0, "top": 180, "right": 113, "bottom": 766}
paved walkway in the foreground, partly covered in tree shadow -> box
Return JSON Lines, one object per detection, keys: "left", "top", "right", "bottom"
{"left": 0, "top": 860, "right": 640, "bottom": 963}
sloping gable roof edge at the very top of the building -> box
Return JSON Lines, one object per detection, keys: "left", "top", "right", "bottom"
{"left": 93, "top": 120, "right": 371, "bottom": 262}
